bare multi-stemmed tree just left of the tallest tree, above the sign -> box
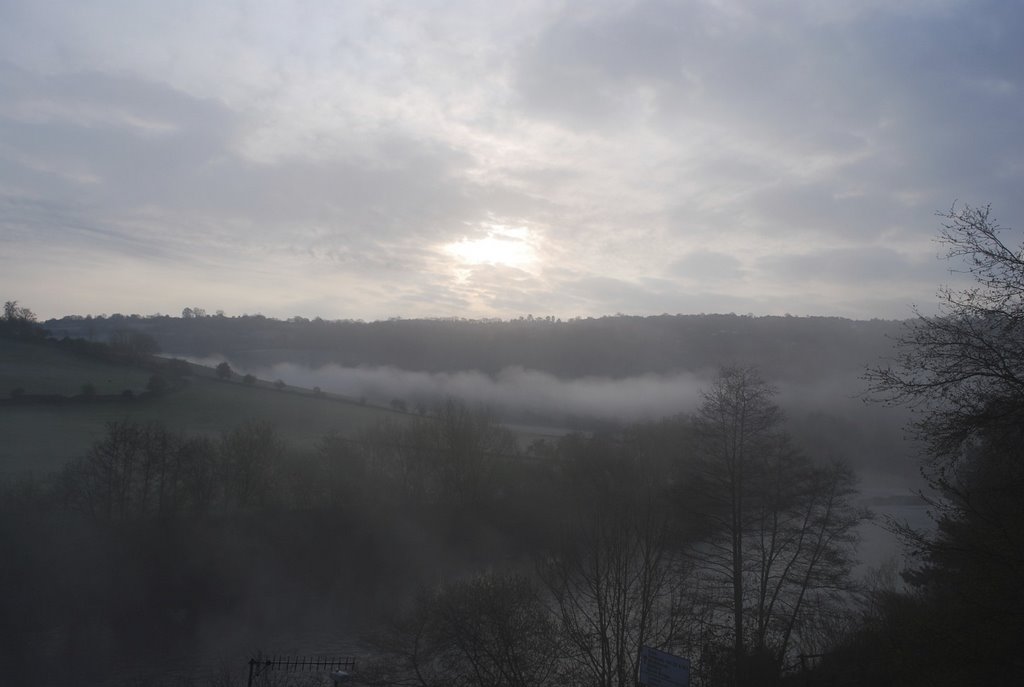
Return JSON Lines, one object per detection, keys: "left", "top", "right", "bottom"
{"left": 538, "top": 439, "right": 689, "bottom": 687}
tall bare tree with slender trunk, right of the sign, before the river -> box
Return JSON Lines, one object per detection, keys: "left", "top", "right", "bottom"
{"left": 680, "top": 368, "right": 866, "bottom": 686}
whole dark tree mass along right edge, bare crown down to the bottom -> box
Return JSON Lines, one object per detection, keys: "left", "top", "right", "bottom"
{"left": 866, "top": 206, "right": 1024, "bottom": 685}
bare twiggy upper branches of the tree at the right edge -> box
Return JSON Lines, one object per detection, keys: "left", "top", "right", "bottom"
{"left": 866, "top": 206, "right": 1024, "bottom": 463}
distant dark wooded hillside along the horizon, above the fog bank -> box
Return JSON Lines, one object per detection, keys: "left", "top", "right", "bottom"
{"left": 45, "top": 314, "right": 899, "bottom": 381}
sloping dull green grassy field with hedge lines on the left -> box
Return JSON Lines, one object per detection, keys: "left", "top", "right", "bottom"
{"left": 0, "top": 340, "right": 400, "bottom": 477}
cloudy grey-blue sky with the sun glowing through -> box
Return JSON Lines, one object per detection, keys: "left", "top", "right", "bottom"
{"left": 0, "top": 0, "right": 1024, "bottom": 320}
